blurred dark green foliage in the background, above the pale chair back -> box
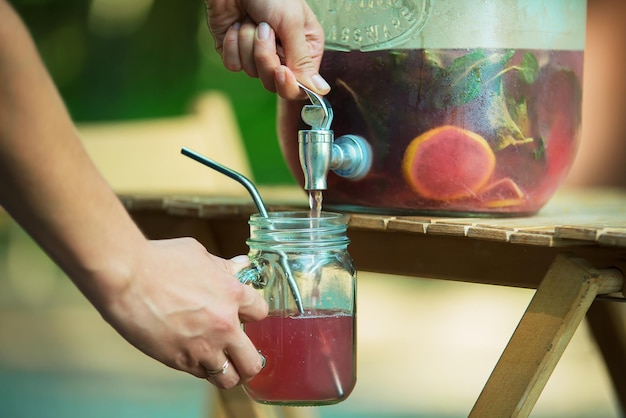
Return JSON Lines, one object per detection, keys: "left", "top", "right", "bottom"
{"left": 11, "top": 0, "right": 295, "bottom": 184}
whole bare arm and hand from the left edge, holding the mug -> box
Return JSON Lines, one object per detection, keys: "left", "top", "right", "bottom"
{"left": 0, "top": 0, "right": 267, "bottom": 387}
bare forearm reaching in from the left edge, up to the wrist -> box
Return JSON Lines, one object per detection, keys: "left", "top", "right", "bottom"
{"left": 0, "top": 0, "right": 145, "bottom": 302}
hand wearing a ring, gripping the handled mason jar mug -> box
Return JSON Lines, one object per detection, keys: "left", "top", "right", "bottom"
{"left": 98, "top": 238, "right": 268, "bottom": 389}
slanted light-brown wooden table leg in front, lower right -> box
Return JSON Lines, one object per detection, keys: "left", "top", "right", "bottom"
{"left": 470, "top": 255, "right": 623, "bottom": 417}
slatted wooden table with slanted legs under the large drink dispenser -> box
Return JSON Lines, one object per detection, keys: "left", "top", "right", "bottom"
{"left": 122, "top": 190, "right": 626, "bottom": 417}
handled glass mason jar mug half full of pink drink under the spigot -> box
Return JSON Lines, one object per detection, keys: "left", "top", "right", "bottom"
{"left": 238, "top": 212, "right": 356, "bottom": 406}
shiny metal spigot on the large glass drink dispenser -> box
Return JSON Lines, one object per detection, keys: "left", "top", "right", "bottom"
{"left": 298, "top": 84, "right": 372, "bottom": 190}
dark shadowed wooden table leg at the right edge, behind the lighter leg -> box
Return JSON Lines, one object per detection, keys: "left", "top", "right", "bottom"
{"left": 587, "top": 300, "right": 626, "bottom": 414}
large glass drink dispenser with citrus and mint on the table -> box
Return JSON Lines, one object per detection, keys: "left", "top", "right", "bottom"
{"left": 278, "top": 0, "right": 586, "bottom": 216}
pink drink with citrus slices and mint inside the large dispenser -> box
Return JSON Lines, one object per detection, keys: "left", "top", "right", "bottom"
{"left": 279, "top": 49, "right": 583, "bottom": 216}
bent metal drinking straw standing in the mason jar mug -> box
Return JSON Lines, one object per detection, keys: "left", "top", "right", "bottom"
{"left": 180, "top": 147, "right": 304, "bottom": 313}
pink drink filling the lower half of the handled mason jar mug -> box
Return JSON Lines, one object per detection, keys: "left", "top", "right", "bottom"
{"left": 244, "top": 310, "right": 356, "bottom": 405}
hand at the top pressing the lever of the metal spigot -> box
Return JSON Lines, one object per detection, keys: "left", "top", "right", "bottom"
{"left": 206, "top": 0, "right": 330, "bottom": 99}
